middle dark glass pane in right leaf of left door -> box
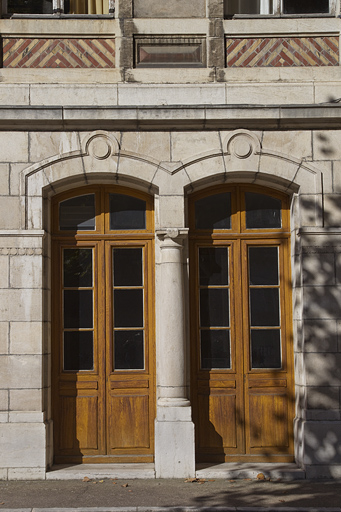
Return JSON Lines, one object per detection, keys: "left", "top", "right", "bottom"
{"left": 114, "top": 289, "right": 143, "bottom": 327}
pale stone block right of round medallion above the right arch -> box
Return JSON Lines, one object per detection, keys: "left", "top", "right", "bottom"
{"left": 262, "top": 130, "right": 312, "bottom": 159}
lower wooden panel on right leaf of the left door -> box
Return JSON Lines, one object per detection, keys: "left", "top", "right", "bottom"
{"left": 108, "top": 391, "right": 150, "bottom": 453}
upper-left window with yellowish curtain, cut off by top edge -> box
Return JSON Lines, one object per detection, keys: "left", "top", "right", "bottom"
{"left": 3, "top": 0, "right": 111, "bottom": 16}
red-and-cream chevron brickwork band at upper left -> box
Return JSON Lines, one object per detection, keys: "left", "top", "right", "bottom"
{"left": 3, "top": 37, "right": 115, "bottom": 68}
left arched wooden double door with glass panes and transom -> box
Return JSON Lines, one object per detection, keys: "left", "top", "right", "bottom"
{"left": 52, "top": 185, "right": 155, "bottom": 463}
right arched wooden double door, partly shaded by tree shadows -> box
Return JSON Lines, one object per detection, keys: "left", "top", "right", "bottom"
{"left": 189, "top": 185, "right": 294, "bottom": 462}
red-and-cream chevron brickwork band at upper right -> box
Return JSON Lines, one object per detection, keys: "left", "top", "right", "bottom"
{"left": 226, "top": 36, "right": 339, "bottom": 68}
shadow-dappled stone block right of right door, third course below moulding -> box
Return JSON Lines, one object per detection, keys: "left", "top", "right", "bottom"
{"left": 303, "top": 318, "right": 338, "bottom": 353}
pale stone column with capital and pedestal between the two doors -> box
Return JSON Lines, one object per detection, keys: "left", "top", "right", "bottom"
{"left": 155, "top": 228, "right": 195, "bottom": 478}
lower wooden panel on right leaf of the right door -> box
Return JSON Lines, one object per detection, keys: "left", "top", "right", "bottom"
{"left": 249, "top": 392, "right": 290, "bottom": 453}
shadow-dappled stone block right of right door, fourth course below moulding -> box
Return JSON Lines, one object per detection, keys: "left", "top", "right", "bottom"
{"left": 304, "top": 352, "right": 341, "bottom": 387}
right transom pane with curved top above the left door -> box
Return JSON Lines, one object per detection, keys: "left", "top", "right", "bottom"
{"left": 110, "top": 194, "right": 146, "bottom": 230}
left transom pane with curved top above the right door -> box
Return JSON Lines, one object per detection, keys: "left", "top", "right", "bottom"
{"left": 195, "top": 192, "right": 231, "bottom": 229}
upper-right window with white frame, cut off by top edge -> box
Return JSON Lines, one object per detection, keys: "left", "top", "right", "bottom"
{"left": 225, "top": 0, "right": 331, "bottom": 17}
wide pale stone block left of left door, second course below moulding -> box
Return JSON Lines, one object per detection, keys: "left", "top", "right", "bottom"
{"left": 0, "top": 289, "right": 42, "bottom": 322}
